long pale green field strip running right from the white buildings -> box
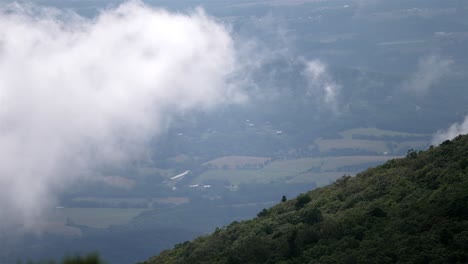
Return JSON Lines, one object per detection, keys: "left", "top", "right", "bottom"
{"left": 193, "top": 156, "right": 395, "bottom": 185}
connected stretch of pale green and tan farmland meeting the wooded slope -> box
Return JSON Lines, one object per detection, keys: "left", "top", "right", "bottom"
{"left": 192, "top": 128, "right": 428, "bottom": 186}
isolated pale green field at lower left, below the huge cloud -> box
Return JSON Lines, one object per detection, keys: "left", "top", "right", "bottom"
{"left": 49, "top": 208, "right": 147, "bottom": 228}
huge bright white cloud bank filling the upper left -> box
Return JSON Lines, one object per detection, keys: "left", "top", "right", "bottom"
{"left": 0, "top": 2, "right": 245, "bottom": 231}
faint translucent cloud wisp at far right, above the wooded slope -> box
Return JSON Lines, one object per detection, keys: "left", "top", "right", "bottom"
{"left": 403, "top": 55, "right": 453, "bottom": 94}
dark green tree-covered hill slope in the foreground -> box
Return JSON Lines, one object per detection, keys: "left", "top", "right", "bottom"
{"left": 144, "top": 136, "right": 468, "bottom": 264}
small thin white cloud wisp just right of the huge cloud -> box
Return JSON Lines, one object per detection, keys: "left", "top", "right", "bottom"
{"left": 304, "top": 60, "right": 341, "bottom": 113}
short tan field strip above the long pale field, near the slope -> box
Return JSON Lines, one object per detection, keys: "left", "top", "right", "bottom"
{"left": 315, "top": 138, "right": 390, "bottom": 153}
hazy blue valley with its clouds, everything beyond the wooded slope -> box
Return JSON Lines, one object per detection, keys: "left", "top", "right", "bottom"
{"left": 0, "top": 0, "right": 468, "bottom": 264}
